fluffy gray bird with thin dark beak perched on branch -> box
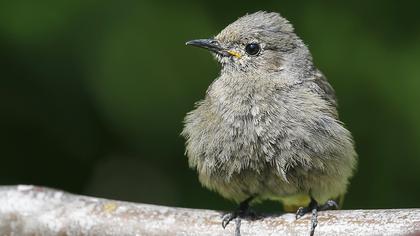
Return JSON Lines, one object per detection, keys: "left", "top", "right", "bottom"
{"left": 182, "top": 12, "right": 357, "bottom": 233}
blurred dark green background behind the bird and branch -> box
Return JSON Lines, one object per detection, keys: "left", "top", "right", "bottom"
{"left": 0, "top": 0, "right": 420, "bottom": 211}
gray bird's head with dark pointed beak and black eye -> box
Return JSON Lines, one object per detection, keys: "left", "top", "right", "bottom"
{"left": 186, "top": 11, "right": 308, "bottom": 73}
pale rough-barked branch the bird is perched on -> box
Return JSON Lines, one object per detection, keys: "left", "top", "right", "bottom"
{"left": 0, "top": 185, "right": 420, "bottom": 236}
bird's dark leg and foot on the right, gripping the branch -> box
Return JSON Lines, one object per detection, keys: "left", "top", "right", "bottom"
{"left": 296, "top": 198, "right": 338, "bottom": 236}
